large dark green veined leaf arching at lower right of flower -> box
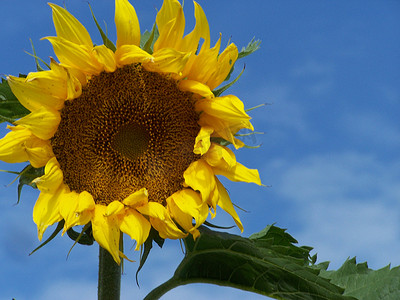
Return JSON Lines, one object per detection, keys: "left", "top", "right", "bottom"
{"left": 145, "top": 226, "right": 354, "bottom": 300}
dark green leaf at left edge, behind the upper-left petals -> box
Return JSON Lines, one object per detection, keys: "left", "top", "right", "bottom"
{"left": 0, "top": 78, "right": 29, "bottom": 123}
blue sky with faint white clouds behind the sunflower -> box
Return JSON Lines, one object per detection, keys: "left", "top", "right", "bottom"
{"left": 0, "top": 0, "right": 400, "bottom": 300}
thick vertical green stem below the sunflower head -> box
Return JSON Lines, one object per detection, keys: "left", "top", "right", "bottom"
{"left": 97, "top": 246, "right": 121, "bottom": 300}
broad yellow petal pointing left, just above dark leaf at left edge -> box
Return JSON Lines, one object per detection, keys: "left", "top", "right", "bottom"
{"left": 7, "top": 75, "right": 65, "bottom": 111}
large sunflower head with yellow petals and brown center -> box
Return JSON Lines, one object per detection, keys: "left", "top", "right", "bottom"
{"left": 0, "top": 0, "right": 261, "bottom": 263}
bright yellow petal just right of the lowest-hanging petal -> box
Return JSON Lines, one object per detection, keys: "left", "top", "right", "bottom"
{"left": 119, "top": 209, "right": 151, "bottom": 250}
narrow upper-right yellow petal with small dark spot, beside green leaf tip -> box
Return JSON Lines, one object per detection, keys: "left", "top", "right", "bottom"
{"left": 207, "top": 44, "right": 239, "bottom": 90}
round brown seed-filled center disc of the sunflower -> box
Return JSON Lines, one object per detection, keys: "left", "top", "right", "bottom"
{"left": 51, "top": 64, "right": 200, "bottom": 204}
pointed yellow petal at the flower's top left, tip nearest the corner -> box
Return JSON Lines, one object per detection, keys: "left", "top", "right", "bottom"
{"left": 49, "top": 3, "right": 93, "bottom": 47}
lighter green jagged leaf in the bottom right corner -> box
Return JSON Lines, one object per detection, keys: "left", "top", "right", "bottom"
{"left": 321, "top": 257, "right": 400, "bottom": 300}
